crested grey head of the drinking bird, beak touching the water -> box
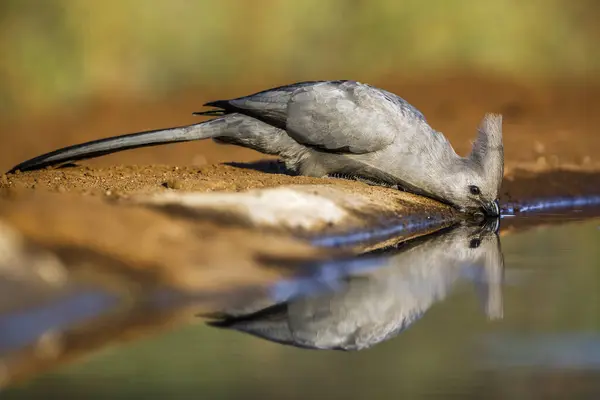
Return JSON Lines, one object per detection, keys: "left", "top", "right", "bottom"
{"left": 438, "top": 114, "right": 504, "bottom": 216}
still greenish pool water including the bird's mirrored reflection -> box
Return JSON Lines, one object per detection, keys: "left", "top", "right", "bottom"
{"left": 2, "top": 213, "right": 600, "bottom": 399}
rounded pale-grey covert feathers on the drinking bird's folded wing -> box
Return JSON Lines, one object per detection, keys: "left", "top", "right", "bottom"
{"left": 286, "top": 81, "right": 402, "bottom": 154}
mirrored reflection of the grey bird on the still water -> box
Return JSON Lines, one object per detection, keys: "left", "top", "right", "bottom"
{"left": 208, "top": 221, "right": 504, "bottom": 351}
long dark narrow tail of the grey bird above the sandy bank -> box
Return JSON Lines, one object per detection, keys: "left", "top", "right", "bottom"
{"left": 9, "top": 118, "right": 222, "bottom": 173}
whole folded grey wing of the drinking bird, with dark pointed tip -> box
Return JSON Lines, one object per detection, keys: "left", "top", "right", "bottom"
{"left": 199, "top": 81, "right": 425, "bottom": 154}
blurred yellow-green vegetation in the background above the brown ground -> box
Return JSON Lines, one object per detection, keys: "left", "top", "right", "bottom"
{"left": 0, "top": 0, "right": 600, "bottom": 113}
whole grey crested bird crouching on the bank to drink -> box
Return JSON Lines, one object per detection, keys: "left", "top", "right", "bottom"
{"left": 10, "top": 81, "right": 504, "bottom": 216}
